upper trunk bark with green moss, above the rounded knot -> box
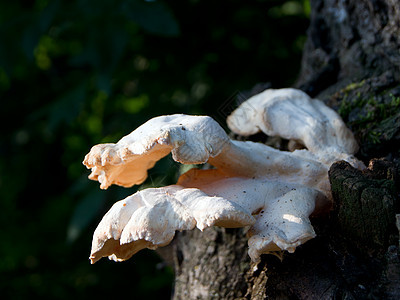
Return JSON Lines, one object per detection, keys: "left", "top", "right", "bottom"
{"left": 296, "top": 0, "right": 400, "bottom": 162}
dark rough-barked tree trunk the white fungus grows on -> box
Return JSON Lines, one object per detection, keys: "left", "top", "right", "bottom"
{"left": 168, "top": 0, "right": 400, "bottom": 299}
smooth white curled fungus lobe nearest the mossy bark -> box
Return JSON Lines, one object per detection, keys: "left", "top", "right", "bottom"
{"left": 227, "top": 88, "right": 365, "bottom": 168}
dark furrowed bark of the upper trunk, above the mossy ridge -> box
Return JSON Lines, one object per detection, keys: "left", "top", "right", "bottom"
{"left": 298, "top": 0, "right": 400, "bottom": 96}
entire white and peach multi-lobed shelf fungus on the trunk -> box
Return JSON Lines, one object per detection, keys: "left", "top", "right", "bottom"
{"left": 83, "top": 89, "right": 364, "bottom": 263}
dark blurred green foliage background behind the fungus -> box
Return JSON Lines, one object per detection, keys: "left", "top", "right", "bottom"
{"left": 0, "top": 0, "right": 310, "bottom": 299}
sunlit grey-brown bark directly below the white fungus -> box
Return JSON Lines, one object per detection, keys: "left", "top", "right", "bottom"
{"left": 174, "top": 228, "right": 249, "bottom": 299}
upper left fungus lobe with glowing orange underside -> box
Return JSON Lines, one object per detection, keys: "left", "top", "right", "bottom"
{"left": 83, "top": 114, "right": 229, "bottom": 189}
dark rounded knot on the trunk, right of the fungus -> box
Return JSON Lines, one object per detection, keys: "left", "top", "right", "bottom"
{"left": 329, "top": 159, "right": 399, "bottom": 253}
